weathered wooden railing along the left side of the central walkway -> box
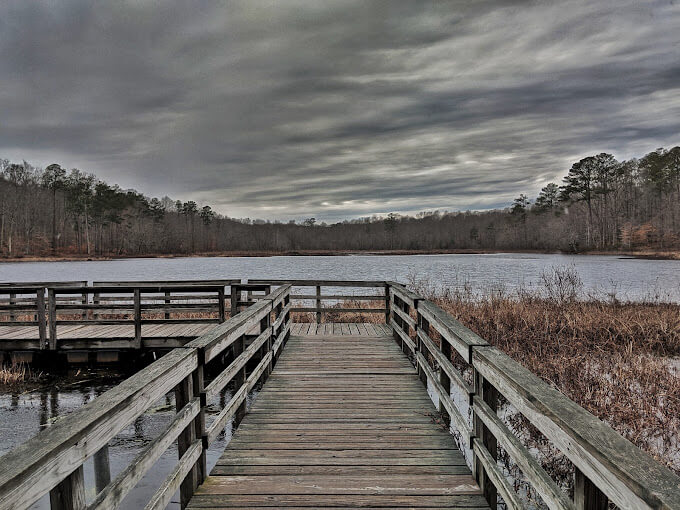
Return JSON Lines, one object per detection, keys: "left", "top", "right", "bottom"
{"left": 0, "top": 286, "right": 291, "bottom": 510}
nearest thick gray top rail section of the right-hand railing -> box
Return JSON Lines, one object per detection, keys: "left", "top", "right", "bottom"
{"left": 473, "top": 347, "right": 680, "bottom": 510}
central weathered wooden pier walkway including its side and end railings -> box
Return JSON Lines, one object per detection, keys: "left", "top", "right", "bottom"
{"left": 0, "top": 280, "right": 680, "bottom": 510}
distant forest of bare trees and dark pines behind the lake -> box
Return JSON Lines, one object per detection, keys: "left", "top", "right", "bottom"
{"left": 0, "top": 147, "right": 680, "bottom": 257}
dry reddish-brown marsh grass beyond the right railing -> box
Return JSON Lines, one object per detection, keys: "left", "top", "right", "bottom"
{"left": 412, "top": 275, "right": 680, "bottom": 473}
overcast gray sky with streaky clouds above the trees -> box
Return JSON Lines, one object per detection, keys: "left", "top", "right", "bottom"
{"left": 0, "top": 0, "right": 680, "bottom": 221}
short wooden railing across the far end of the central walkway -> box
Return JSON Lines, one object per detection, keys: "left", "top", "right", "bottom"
{"left": 249, "top": 280, "right": 389, "bottom": 324}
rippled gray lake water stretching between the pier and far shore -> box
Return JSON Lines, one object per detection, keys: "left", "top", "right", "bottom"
{"left": 0, "top": 253, "right": 680, "bottom": 301}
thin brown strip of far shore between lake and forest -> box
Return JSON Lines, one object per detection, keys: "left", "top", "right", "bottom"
{"left": 0, "top": 249, "right": 680, "bottom": 263}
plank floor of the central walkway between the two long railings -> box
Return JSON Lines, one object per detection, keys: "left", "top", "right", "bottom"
{"left": 189, "top": 324, "right": 488, "bottom": 510}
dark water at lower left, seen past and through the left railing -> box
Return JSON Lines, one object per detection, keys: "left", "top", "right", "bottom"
{"left": 0, "top": 370, "right": 255, "bottom": 510}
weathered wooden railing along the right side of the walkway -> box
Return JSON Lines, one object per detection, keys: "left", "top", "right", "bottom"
{"left": 388, "top": 282, "right": 680, "bottom": 510}
